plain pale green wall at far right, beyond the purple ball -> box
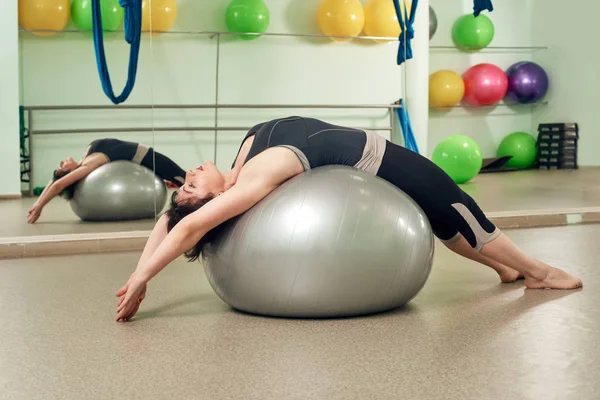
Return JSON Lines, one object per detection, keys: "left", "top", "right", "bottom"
{"left": 532, "top": 0, "right": 600, "bottom": 166}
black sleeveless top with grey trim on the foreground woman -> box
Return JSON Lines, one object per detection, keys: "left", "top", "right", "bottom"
{"left": 234, "top": 117, "right": 385, "bottom": 174}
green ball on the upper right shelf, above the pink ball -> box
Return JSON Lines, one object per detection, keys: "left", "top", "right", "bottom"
{"left": 452, "top": 14, "right": 495, "bottom": 50}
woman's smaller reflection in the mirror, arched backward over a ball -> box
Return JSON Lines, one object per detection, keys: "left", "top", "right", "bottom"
{"left": 27, "top": 139, "right": 185, "bottom": 224}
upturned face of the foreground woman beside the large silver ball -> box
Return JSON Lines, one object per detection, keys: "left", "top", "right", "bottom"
{"left": 177, "top": 161, "right": 225, "bottom": 201}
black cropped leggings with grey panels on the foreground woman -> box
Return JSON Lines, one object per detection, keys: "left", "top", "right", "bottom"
{"left": 377, "top": 141, "right": 500, "bottom": 251}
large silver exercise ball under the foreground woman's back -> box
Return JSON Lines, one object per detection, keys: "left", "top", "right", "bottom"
{"left": 204, "top": 166, "right": 434, "bottom": 318}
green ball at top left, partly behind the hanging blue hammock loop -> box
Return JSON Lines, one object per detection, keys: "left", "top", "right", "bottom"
{"left": 71, "top": 0, "right": 124, "bottom": 31}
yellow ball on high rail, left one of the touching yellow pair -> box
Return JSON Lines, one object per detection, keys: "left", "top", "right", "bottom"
{"left": 317, "top": 0, "right": 364, "bottom": 42}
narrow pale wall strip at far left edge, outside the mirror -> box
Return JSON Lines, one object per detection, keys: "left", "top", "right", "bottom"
{"left": 0, "top": 1, "right": 21, "bottom": 195}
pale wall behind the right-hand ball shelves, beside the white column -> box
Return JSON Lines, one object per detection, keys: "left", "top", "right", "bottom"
{"left": 428, "top": 0, "right": 536, "bottom": 157}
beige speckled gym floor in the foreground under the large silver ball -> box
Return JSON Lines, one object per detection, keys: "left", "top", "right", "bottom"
{"left": 0, "top": 225, "right": 600, "bottom": 400}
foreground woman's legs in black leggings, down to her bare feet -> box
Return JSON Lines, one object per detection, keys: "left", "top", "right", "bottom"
{"left": 377, "top": 142, "right": 582, "bottom": 289}
